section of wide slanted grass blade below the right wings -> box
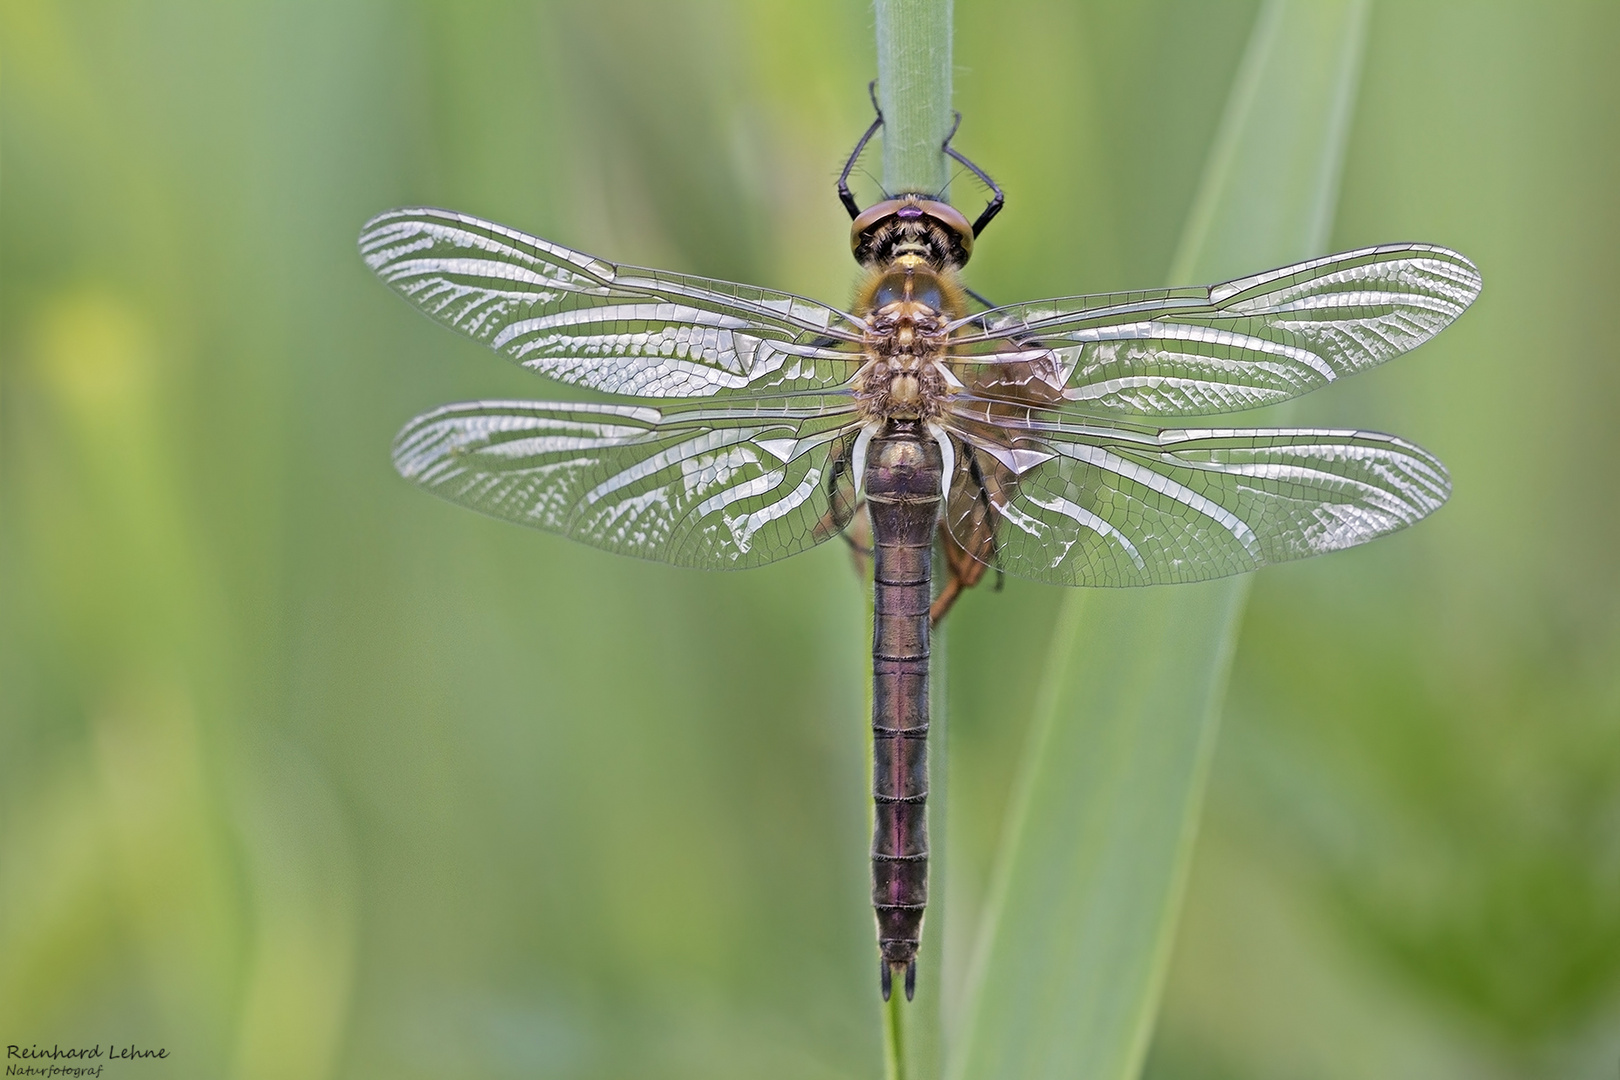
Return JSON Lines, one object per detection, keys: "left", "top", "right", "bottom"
{"left": 951, "top": 581, "right": 1243, "bottom": 1078}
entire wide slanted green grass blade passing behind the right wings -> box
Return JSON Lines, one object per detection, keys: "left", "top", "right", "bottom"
{"left": 946, "top": 0, "right": 1367, "bottom": 1080}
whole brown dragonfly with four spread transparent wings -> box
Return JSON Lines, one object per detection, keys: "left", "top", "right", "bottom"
{"left": 360, "top": 101, "right": 1481, "bottom": 1001}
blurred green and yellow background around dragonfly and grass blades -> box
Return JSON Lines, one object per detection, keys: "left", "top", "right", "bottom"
{"left": 0, "top": 0, "right": 1620, "bottom": 1080}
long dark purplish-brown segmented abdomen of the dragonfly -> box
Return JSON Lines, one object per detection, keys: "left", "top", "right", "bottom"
{"left": 865, "top": 421, "right": 943, "bottom": 997}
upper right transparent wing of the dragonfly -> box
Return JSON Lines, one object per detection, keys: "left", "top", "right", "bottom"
{"left": 953, "top": 244, "right": 1479, "bottom": 416}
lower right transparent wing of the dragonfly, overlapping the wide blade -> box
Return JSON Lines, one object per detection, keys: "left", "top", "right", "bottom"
{"left": 949, "top": 411, "right": 1452, "bottom": 586}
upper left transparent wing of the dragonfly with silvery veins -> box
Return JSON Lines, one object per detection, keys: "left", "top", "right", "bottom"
{"left": 360, "top": 209, "right": 860, "bottom": 397}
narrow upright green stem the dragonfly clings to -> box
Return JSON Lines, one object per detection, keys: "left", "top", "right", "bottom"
{"left": 876, "top": 0, "right": 951, "bottom": 1080}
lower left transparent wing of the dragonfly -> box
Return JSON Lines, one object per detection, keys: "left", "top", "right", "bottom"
{"left": 394, "top": 400, "right": 855, "bottom": 570}
